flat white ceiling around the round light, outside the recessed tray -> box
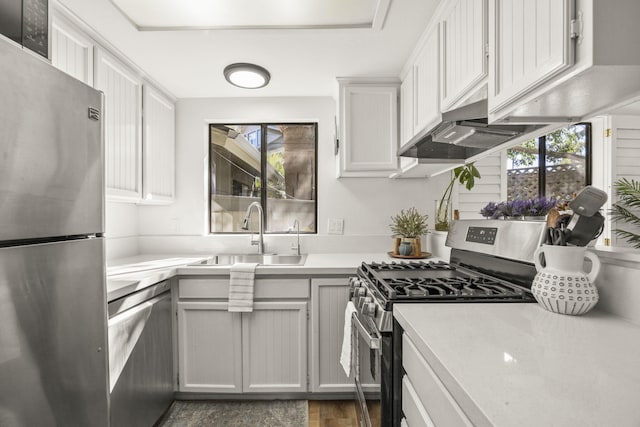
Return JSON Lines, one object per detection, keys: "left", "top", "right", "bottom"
{"left": 58, "top": 0, "right": 438, "bottom": 98}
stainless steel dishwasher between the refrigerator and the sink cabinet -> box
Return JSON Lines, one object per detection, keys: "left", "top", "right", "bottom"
{"left": 108, "top": 281, "right": 173, "bottom": 427}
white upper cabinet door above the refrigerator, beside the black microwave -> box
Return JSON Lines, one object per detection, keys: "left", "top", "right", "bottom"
{"left": 51, "top": 17, "right": 95, "bottom": 86}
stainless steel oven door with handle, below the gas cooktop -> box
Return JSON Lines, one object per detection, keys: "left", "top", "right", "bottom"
{"left": 351, "top": 314, "right": 382, "bottom": 427}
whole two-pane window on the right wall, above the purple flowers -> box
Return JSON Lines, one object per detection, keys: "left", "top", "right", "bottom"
{"left": 507, "top": 123, "right": 591, "bottom": 201}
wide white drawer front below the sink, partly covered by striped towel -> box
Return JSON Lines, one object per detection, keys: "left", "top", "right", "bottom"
{"left": 178, "top": 278, "right": 309, "bottom": 299}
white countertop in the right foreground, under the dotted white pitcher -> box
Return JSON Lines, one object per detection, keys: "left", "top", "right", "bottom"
{"left": 394, "top": 303, "right": 640, "bottom": 427}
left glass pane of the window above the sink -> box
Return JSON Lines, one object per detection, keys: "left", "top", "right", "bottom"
{"left": 209, "top": 125, "right": 261, "bottom": 233}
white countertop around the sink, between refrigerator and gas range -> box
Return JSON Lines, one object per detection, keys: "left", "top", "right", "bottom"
{"left": 107, "top": 253, "right": 412, "bottom": 301}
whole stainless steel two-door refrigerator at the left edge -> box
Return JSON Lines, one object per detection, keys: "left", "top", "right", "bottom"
{"left": 0, "top": 38, "right": 109, "bottom": 426}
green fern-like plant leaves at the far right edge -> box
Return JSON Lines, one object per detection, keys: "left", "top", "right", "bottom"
{"left": 611, "top": 178, "right": 640, "bottom": 249}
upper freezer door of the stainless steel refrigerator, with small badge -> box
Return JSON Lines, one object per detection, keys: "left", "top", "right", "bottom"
{"left": 0, "top": 40, "right": 104, "bottom": 241}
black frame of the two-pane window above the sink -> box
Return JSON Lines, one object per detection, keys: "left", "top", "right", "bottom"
{"left": 207, "top": 121, "right": 319, "bottom": 235}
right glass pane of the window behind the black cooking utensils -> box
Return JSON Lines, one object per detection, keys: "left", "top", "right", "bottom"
{"left": 545, "top": 124, "right": 587, "bottom": 200}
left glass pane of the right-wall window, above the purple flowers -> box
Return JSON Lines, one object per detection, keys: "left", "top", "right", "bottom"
{"left": 507, "top": 139, "right": 539, "bottom": 201}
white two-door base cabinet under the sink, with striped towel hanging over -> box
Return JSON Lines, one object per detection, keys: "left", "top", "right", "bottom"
{"left": 177, "top": 278, "right": 309, "bottom": 393}
